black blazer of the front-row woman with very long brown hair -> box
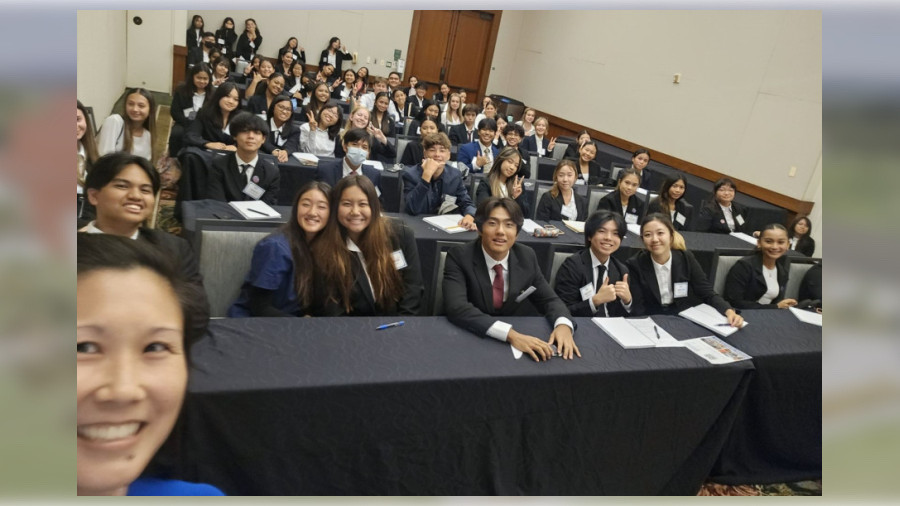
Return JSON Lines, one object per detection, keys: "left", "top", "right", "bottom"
{"left": 313, "top": 217, "right": 425, "bottom": 316}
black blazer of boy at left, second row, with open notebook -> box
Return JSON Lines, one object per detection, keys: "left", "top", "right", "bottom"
{"left": 208, "top": 153, "right": 281, "bottom": 206}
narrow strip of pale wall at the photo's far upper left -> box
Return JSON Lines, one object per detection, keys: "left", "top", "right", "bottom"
{"left": 76, "top": 10, "right": 126, "bottom": 120}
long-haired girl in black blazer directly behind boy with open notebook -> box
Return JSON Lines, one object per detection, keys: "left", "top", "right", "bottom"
{"left": 184, "top": 83, "right": 241, "bottom": 151}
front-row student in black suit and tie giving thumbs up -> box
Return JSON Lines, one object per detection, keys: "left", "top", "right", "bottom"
{"left": 556, "top": 209, "right": 632, "bottom": 317}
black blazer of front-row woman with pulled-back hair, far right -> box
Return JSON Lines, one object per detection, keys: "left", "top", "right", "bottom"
{"left": 724, "top": 252, "right": 791, "bottom": 309}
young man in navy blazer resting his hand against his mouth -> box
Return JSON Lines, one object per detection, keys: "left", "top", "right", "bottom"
{"left": 402, "top": 133, "right": 475, "bottom": 230}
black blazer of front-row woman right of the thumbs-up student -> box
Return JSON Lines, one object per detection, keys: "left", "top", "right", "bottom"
{"left": 626, "top": 250, "right": 731, "bottom": 315}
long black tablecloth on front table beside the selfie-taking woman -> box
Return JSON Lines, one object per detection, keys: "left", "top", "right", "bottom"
{"left": 157, "top": 317, "right": 752, "bottom": 495}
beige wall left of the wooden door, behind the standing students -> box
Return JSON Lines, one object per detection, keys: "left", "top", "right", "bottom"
{"left": 192, "top": 10, "right": 413, "bottom": 76}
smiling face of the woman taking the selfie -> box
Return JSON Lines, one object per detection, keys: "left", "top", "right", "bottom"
{"left": 76, "top": 268, "right": 187, "bottom": 495}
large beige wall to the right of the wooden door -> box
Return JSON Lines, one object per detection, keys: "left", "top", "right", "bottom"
{"left": 488, "top": 11, "right": 822, "bottom": 218}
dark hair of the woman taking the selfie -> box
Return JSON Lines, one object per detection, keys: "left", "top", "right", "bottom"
{"left": 76, "top": 233, "right": 209, "bottom": 356}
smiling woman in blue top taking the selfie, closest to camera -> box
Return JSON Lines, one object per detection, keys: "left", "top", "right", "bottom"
{"left": 75, "top": 234, "right": 224, "bottom": 496}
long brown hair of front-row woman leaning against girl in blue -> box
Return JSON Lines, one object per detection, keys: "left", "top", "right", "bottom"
{"left": 313, "top": 176, "right": 403, "bottom": 313}
